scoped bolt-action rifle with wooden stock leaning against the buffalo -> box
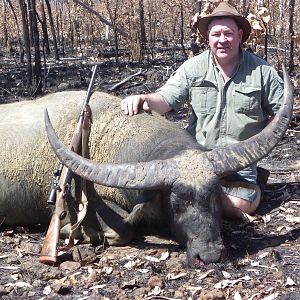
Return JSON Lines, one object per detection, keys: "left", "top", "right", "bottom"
{"left": 39, "top": 65, "right": 97, "bottom": 264}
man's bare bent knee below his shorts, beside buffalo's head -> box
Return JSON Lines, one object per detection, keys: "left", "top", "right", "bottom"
{"left": 221, "top": 186, "right": 261, "bottom": 218}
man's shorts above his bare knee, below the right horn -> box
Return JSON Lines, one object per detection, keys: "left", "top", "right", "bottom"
{"left": 221, "top": 165, "right": 259, "bottom": 202}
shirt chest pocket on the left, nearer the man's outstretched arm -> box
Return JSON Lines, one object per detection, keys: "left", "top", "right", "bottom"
{"left": 190, "top": 86, "right": 218, "bottom": 115}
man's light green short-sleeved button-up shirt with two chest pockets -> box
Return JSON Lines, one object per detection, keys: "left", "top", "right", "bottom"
{"left": 157, "top": 50, "right": 283, "bottom": 150}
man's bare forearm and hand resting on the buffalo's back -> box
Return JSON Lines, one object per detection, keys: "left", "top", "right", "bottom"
{"left": 121, "top": 93, "right": 172, "bottom": 116}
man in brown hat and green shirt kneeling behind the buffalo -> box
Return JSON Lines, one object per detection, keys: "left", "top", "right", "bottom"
{"left": 121, "top": 2, "right": 283, "bottom": 218}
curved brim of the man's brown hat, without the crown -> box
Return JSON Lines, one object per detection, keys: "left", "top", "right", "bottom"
{"left": 197, "top": 13, "right": 251, "bottom": 43}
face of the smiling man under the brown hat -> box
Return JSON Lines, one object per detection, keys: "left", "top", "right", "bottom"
{"left": 208, "top": 18, "right": 243, "bottom": 64}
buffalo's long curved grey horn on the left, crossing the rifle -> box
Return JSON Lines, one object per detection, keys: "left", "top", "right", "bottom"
{"left": 45, "top": 110, "right": 176, "bottom": 189}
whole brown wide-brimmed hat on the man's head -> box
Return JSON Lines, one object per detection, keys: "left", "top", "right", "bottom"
{"left": 196, "top": 2, "right": 251, "bottom": 43}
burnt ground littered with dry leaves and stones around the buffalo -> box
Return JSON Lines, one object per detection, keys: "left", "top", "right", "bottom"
{"left": 0, "top": 56, "right": 300, "bottom": 300}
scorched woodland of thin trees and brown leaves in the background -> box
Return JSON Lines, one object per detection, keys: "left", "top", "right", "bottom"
{"left": 0, "top": 0, "right": 300, "bottom": 96}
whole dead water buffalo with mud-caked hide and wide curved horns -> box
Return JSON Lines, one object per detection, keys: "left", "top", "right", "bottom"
{"left": 0, "top": 66, "right": 292, "bottom": 266}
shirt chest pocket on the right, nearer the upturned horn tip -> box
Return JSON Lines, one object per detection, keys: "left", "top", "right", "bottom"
{"left": 234, "top": 84, "right": 261, "bottom": 117}
